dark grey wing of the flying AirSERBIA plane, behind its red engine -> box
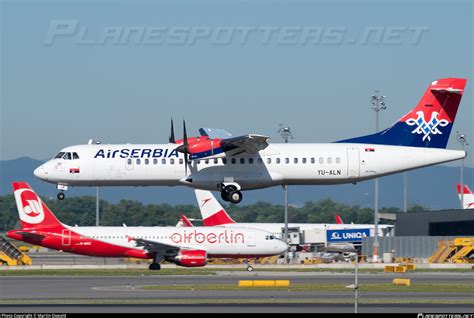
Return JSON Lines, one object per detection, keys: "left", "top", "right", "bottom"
{"left": 221, "top": 134, "right": 270, "bottom": 155}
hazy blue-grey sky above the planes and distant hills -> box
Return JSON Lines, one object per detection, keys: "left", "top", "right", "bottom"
{"left": 0, "top": 0, "right": 474, "bottom": 166}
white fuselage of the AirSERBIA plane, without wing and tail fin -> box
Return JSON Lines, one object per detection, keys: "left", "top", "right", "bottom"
{"left": 35, "top": 143, "right": 466, "bottom": 191}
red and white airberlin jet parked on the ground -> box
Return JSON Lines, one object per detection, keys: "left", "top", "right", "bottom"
{"left": 7, "top": 182, "right": 287, "bottom": 270}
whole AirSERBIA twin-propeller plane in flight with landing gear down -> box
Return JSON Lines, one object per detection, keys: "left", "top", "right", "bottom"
{"left": 34, "top": 78, "right": 466, "bottom": 203}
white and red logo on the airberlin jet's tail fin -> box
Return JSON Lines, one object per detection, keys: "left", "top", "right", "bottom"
{"left": 15, "top": 189, "right": 44, "bottom": 224}
